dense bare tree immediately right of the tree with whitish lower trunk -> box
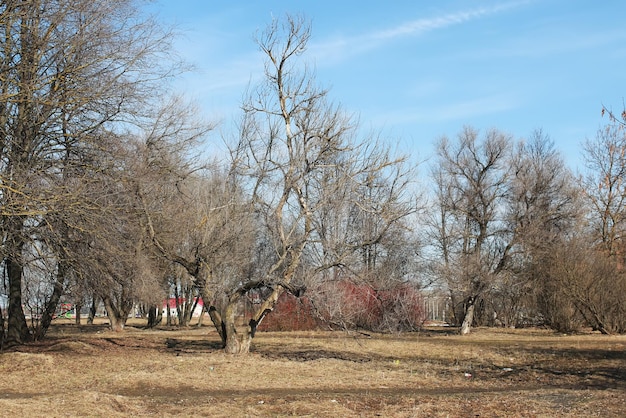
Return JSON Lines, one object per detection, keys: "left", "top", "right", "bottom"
{"left": 502, "top": 130, "right": 582, "bottom": 325}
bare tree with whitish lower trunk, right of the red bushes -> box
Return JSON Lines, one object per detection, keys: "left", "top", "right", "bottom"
{"left": 433, "top": 128, "right": 511, "bottom": 334}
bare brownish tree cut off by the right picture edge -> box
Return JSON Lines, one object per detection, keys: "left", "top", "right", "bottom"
{"left": 572, "top": 121, "right": 626, "bottom": 333}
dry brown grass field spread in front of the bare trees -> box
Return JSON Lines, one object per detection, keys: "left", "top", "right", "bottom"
{"left": 0, "top": 321, "right": 626, "bottom": 417}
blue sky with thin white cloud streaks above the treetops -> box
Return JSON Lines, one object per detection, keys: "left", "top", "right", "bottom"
{"left": 144, "top": 0, "right": 626, "bottom": 170}
